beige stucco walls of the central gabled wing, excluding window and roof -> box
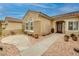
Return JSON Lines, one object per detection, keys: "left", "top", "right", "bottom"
{"left": 23, "top": 12, "right": 51, "bottom": 35}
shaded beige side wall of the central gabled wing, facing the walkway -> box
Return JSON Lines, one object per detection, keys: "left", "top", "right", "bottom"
{"left": 39, "top": 16, "right": 52, "bottom": 35}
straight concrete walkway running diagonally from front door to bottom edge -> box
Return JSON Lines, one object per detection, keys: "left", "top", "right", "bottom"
{"left": 21, "top": 34, "right": 63, "bottom": 56}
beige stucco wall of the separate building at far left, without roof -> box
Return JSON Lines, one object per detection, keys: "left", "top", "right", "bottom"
{"left": 2, "top": 22, "right": 22, "bottom": 36}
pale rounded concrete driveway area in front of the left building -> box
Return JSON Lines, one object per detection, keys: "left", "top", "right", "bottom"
{"left": 1, "top": 35, "right": 31, "bottom": 51}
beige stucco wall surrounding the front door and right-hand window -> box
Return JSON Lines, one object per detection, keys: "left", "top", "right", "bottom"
{"left": 52, "top": 18, "right": 79, "bottom": 34}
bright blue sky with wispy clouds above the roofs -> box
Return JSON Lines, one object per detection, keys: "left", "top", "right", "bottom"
{"left": 0, "top": 3, "right": 79, "bottom": 20}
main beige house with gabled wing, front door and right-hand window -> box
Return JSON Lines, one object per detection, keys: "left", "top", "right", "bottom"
{"left": 23, "top": 11, "right": 79, "bottom": 35}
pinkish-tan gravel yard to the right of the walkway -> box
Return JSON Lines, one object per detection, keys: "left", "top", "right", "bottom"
{"left": 43, "top": 34, "right": 79, "bottom": 56}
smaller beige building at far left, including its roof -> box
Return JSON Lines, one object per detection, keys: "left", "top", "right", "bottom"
{"left": 2, "top": 17, "right": 22, "bottom": 36}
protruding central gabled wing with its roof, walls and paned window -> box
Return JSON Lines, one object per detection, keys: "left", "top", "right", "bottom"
{"left": 23, "top": 11, "right": 52, "bottom": 35}
